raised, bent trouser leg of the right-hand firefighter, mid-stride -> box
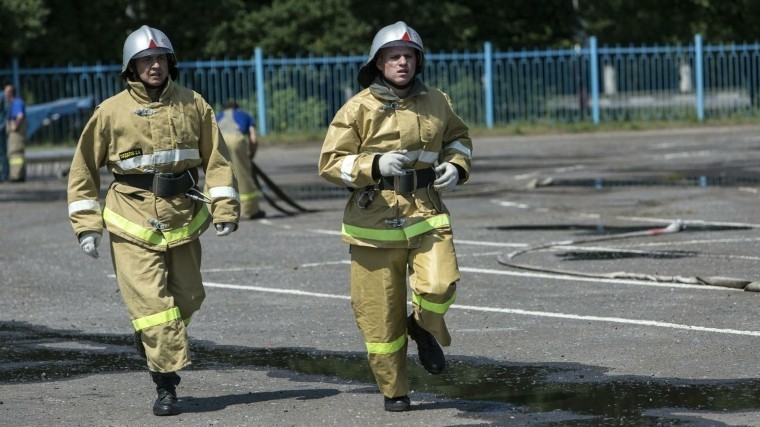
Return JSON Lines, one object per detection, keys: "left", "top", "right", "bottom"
{"left": 409, "top": 229, "right": 460, "bottom": 346}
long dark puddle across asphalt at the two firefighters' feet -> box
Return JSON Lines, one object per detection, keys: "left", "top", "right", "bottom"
{"left": 0, "top": 322, "right": 760, "bottom": 426}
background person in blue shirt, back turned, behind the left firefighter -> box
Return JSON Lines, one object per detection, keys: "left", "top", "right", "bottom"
{"left": 216, "top": 100, "right": 266, "bottom": 219}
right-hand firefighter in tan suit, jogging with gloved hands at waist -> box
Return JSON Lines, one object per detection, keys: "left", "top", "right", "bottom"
{"left": 319, "top": 21, "right": 472, "bottom": 412}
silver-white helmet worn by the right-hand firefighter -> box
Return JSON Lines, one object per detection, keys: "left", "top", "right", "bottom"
{"left": 356, "top": 21, "right": 425, "bottom": 88}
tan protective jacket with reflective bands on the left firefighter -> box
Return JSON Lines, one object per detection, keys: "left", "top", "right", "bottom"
{"left": 68, "top": 79, "right": 240, "bottom": 250}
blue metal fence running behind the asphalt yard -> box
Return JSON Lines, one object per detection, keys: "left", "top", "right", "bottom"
{"left": 0, "top": 35, "right": 760, "bottom": 143}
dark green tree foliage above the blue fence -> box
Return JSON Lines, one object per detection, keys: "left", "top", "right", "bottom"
{"left": 0, "top": 0, "right": 760, "bottom": 67}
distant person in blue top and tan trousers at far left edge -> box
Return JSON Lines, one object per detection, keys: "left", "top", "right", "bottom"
{"left": 3, "top": 84, "right": 26, "bottom": 182}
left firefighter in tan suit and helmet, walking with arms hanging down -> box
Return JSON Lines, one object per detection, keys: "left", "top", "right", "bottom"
{"left": 68, "top": 26, "right": 240, "bottom": 415}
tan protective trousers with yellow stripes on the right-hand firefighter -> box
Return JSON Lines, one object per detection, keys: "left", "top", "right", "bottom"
{"left": 351, "top": 230, "right": 460, "bottom": 397}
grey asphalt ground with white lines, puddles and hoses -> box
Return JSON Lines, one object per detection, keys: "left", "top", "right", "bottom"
{"left": 0, "top": 127, "right": 760, "bottom": 426}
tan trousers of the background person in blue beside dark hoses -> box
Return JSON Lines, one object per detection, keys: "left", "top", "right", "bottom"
{"left": 222, "top": 132, "right": 261, "bottom": 218}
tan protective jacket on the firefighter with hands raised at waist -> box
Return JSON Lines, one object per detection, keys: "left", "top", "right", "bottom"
{"left": 319, "top": 77, "right": 472, "bottom": 248}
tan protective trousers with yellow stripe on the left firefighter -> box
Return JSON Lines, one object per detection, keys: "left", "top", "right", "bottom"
{"left": 109, "top": 234, "right": 206, "bottom": 372}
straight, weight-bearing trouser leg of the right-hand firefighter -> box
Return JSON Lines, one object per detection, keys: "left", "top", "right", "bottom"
{"left": 351, "top": 246, "right": 409, "bottom": 397}
